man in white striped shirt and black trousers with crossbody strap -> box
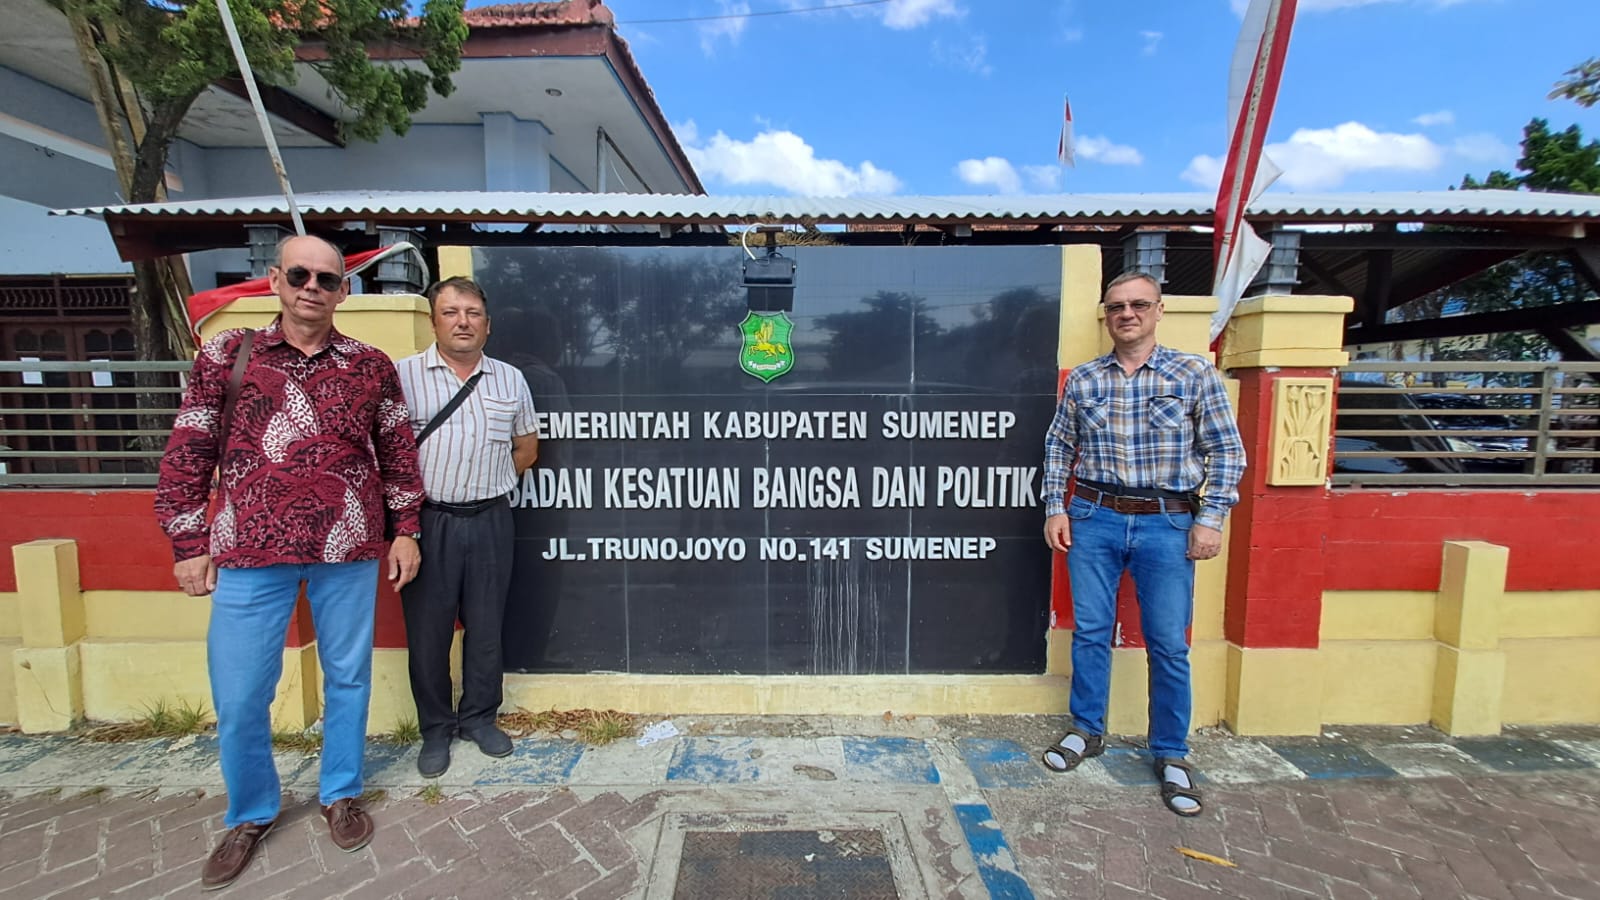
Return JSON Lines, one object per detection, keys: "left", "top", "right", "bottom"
{"left": 395, "top": 277, "right": 539, "bottom": 778}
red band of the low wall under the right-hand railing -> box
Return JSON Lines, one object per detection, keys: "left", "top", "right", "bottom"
{"left": 1323, "top": 490, "right": 1600, "bottom": 591}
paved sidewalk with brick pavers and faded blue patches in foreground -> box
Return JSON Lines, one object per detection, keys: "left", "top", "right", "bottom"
{"left": 0, "top": 716, "right": 1600, "bottom": 900}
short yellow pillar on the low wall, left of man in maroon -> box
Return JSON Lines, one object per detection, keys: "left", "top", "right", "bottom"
{"left": 11, "top": 540, "right": 86, "bottom": 733}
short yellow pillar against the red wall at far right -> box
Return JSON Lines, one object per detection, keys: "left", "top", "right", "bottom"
{"left": 1434, "top": 541, "right": 1510, "bottom": 735}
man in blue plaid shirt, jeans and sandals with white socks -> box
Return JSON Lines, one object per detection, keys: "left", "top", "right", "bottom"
{"left": 1043, "top": 272, "right": 1245, "bottom": 815}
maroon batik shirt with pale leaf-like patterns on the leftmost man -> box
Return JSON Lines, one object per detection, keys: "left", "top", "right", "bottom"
{"left": 155, "top": 322, "right": 422, "bottom": 569}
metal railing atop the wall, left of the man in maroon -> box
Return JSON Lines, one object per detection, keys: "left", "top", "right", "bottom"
{"left": 0, "top": 360, "right": 192, "bottom": 487}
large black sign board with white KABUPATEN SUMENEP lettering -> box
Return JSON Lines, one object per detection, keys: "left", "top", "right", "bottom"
{"left": 474, "top": 247, "right": 1061, "bottom": 674}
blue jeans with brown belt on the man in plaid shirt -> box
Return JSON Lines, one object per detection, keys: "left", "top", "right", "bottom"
{"left": 1067, "top": 496, "right": 1195, "bottom": 759}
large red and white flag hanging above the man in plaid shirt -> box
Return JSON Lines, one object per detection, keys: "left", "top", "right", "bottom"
{"left": 1211, "top": 0, "right": 1298, "bottom": 348}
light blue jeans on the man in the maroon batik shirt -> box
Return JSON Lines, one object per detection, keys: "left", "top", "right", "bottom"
{"left": 206, "top": 559, "right": 378, "bottom": 828}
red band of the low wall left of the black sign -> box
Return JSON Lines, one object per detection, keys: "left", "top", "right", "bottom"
{"left": 0, "top": 490, "right": 405, "bottom": 647}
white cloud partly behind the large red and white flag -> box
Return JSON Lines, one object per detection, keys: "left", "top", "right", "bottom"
{"left": 1182, "top": 122, "right": 1445, "bottom": 191}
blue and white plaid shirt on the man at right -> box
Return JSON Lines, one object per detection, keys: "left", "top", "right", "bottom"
{"left": 1045, "top": 344, "right": 1245, "bottom": 528}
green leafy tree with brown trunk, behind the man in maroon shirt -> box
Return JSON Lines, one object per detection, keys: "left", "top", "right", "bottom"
{"left": 50, "top": 0, "right": 467, "bottom": 359}
